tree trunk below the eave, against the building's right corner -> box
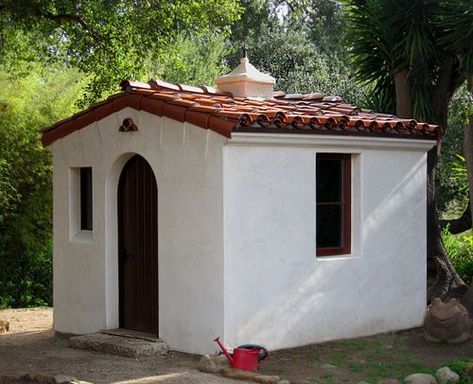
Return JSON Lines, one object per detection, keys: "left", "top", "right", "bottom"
{"left": 427, "top": 146, "right": 467, "bottom": 301}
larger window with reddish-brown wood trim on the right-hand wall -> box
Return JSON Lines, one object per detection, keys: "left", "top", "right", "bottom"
{"left": 316, "top": 153, "right": 351, "bottom": 256}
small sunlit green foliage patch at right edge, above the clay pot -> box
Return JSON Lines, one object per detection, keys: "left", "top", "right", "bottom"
{"left": 442, "top": 228, "right": 473, "bottom": 285}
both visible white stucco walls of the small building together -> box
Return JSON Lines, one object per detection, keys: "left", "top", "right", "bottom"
{"left": 51, "top": 108, "right": 429, "bottom": 353}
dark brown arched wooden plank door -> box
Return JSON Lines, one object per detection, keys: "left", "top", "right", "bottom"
{"left": 118, "top": 155, "right": 158, "bottom": 334}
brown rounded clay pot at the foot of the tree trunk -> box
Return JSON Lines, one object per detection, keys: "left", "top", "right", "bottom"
{"left": 424, "top": 297, "right": 472, "bottom": 344}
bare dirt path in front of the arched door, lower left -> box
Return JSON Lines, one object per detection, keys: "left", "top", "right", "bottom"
{"left": 0, "top": 308, "right": 249, "bottom": 384}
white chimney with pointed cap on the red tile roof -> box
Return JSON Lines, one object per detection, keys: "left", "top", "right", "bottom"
{"left": 215, "top": 57, "right": 275, "bottom": 99}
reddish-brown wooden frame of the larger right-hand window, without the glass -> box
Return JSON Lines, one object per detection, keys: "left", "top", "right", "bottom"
{"left": 315, "top": 153, "right": 352, "bottom": 256}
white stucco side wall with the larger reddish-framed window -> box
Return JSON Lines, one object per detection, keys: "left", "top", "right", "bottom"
{"left": 224, "top": 134, "right": 434, "bottom": 349}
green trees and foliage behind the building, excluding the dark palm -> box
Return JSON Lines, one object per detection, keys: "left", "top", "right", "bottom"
{"left": 0, "top": 0, "right": 473, "bottom": 308}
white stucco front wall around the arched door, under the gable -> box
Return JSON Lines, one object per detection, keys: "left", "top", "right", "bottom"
{"left": 51, "top": 108, "right": 226, "bottom": 353}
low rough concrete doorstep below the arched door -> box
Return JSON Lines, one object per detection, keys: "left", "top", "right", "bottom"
{"left": 69, "top": 330, "right": 169, "bottom": 358}
